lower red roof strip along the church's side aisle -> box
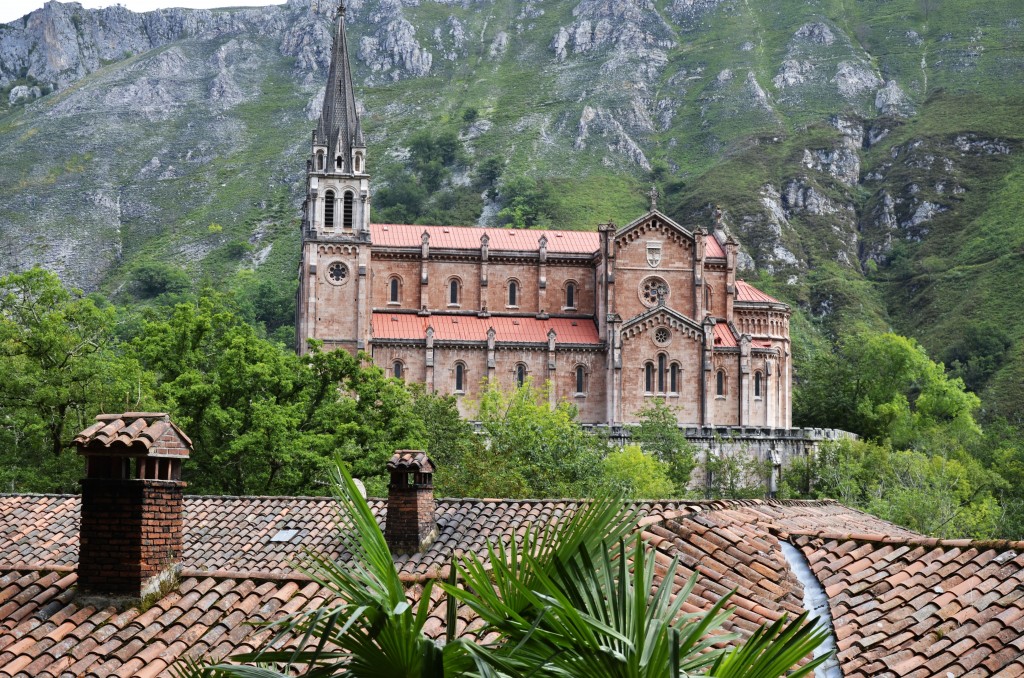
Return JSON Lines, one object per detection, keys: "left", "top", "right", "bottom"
{"left": 372, "top": 311, "right": 601, "bottom": 346}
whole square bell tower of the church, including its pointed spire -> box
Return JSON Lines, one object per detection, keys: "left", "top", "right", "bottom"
{"left": 295, "top": 1, "right": 370, "bottom": 353}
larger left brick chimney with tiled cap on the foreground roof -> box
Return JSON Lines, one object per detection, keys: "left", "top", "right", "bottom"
{"left": 75, "top": 412, "right": 191, "bottom": 598}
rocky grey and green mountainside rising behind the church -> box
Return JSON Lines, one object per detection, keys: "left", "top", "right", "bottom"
{"left": 0, "top": 0, "right": 1024, "bottom": 417}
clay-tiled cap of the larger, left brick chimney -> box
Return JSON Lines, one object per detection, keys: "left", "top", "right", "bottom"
{"left": 75, "top": 412, "right": 193, "bottom": 457}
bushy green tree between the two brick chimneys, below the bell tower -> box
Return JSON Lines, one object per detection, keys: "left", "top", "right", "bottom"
{"left": 133, "top": 293, "right": 424, "bottom": 495}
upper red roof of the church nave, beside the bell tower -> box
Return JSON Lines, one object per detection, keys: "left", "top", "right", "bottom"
{"left": 370, "top": 223, "right": 601, "bottom": 254}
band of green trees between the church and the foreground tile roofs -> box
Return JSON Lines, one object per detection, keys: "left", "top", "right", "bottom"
{"left": 0, "top": 265, "right": 1024, "bottom": 539}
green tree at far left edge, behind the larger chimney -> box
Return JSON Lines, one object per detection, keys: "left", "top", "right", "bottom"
{"left": 0, "top": 268, "right": 154, "bottom": 492}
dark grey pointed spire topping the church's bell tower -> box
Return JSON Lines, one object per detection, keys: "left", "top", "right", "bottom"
{"left": 313, "top": 0, "right": 364, "bottom": 173}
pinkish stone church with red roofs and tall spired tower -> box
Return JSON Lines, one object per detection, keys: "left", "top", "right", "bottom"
{"left": 296, "top": 5, "right": 793, "bottom": 429}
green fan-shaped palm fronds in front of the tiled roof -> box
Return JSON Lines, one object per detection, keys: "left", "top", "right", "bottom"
{"left": 179, "top": 469, "right": 828, "bottom": 678}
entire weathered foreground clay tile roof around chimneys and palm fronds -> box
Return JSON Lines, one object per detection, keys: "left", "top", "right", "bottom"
{"left": 0, "top": 493, "right": 1024, "bottom": 676}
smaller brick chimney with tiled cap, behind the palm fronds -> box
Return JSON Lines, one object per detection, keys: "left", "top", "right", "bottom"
{"left": 384, "top": 450, "right": 437, "bottom": 555}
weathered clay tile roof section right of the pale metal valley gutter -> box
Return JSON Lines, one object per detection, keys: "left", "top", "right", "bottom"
{"left": 794, "top": 535, "right": 1024, "bottom": 676}
